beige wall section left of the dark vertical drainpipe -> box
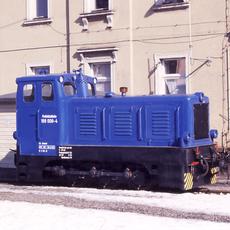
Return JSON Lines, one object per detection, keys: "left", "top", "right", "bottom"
{"left": 0, "top": 0, "right": 66, "bottom": 95}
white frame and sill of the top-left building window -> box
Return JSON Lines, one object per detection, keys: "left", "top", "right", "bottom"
{"left": 24, "top": 0, "right": 52, "bottom": 25}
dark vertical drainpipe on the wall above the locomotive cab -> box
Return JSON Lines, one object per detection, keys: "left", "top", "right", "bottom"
{"left": 66, "top": 0, "right": 70, "bottom": 73}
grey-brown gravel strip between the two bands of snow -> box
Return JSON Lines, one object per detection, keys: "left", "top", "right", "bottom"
{"left": 0, "top": 184, "right": 230, "bottom": 223}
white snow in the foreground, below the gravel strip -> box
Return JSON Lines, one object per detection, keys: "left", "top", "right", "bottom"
{"left": 0, "top": 201, "right": 230, "bottom": 230}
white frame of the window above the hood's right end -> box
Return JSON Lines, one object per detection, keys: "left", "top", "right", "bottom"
{"left": 155, "top": 54, "right": 190, "bottom": 95}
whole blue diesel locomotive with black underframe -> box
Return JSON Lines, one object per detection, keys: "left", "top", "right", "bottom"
{"left": 14, "top": 71, "right": 218, "bottom": 191}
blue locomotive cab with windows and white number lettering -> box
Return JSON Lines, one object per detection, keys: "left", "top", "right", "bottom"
{"left": 14, "top": 73, "right": 96, "bottom": 181}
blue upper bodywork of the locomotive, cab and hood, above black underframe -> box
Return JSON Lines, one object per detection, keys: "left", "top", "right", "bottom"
{"left": 16, "top": 72, "right": 212, "bottom": 156}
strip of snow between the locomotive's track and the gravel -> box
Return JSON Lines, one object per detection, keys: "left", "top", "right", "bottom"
{"left": 0, "top": 187, "right": 230, "bottom": 216}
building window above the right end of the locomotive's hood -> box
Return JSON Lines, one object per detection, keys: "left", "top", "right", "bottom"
{"left": 156, "top": 57, "right": 186, "bottom": 94}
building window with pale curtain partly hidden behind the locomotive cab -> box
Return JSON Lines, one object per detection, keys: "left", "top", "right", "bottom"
{"left": 89, "top": 62, "right": 111, "bottom": 92}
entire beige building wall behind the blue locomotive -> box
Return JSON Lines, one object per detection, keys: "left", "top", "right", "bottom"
{"left": 0, "top": 0, "right": 230, "bottom": 147}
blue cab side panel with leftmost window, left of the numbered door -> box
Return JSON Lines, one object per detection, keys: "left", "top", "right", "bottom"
{"left": 17, "top": 82, "right": 38, "bottom": 155}
